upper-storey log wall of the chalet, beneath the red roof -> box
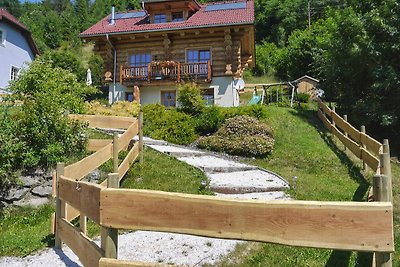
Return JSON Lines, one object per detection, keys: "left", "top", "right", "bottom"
{"left": 87, "top": 25, "right": 254, "bottom": 82}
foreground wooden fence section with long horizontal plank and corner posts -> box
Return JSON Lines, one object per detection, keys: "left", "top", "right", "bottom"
{"left": 56, "top": 109, "right": 394, "bottom": 267}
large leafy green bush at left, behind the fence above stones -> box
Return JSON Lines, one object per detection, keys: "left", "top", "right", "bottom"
{"left": 10, "top": 58, "right": 93, "bottom": 168}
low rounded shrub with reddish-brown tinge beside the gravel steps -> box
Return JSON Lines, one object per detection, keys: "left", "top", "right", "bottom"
{"left": 198, "top": 116, "right": 275, "bottom": 157}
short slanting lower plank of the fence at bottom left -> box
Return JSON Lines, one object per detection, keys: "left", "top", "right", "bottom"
{"left": 58, "top": 219, "right": 104, "bottom": 267}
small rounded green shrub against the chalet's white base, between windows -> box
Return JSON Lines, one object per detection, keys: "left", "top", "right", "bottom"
{"left": 177, "top": 83, "right": 205, "bottom": 114}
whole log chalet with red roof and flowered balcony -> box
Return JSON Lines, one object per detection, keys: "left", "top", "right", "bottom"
{"left": 80, "top": 0, "right": 255, "bottom": 106}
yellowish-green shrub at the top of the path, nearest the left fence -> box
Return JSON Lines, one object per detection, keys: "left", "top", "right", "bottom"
{"left": 143, "top": 104, "right": 198, "bottom": 145}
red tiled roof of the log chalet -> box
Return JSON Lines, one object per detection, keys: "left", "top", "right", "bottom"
{"left": 80, "top": 0, "right": 254, "bottom": 37}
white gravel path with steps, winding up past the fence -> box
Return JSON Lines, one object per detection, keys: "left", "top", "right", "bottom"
{"left": 0, "top": 139, "right": 289, "bottom": 267}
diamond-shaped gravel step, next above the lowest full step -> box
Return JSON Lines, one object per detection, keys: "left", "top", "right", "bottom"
{"left": 178, "top": 156, "right": 256, "bottom": 173}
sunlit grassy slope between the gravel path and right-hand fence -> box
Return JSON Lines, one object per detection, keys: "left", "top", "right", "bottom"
{"left": 212, "top": 106, "right": 384, "bottom": 266}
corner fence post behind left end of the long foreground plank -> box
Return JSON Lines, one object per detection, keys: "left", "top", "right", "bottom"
{"left": 101, "top": 173, "right": 119, "bottom": 259}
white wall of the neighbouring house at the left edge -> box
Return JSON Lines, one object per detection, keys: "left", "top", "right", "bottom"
{"left": 0, "top": 22, "right": 34, "bottom": 88}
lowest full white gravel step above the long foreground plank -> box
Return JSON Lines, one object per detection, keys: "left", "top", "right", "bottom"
{"left": 207, "top": 170, "right": 289, "bottom": 194}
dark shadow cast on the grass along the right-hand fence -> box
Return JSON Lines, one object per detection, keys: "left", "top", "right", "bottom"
{"left": 291, "top": 108, "right": 373, "bottom": 267}
